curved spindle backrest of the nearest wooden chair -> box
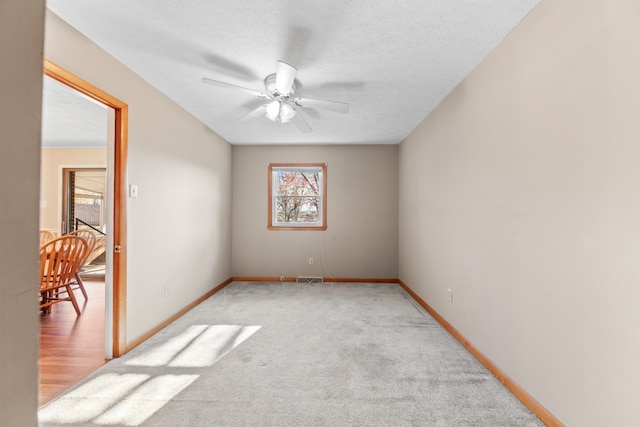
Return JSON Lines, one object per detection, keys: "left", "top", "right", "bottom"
{"left": 40, "top": 235, "right": 88, "bottom": 291}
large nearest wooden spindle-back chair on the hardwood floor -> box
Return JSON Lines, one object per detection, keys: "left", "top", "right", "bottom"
{"left": 40, "top": 235, "right": 88, "bottom": 316}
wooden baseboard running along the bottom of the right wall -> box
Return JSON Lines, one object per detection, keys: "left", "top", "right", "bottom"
{"left": 398, "top": 280, "right": 564, "bottom": 427}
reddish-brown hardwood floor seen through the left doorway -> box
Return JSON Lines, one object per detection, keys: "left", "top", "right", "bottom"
{"left": 39, "top": 279, "right": 106, "bottom": 405}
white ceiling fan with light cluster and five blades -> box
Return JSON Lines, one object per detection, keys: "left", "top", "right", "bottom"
{"left": 202, "top": 61, "right": 349, "bottom": 133}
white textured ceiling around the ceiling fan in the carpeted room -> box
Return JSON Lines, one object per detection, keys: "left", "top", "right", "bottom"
{"left": 47, "top": 0, "right": 539, "bottom": 144}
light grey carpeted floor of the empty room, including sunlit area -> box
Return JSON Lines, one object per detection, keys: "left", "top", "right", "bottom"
{"left": 39, "top": 282, "right": 543, "bottom": 427}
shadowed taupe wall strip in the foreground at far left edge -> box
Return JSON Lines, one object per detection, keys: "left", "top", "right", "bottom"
{"left": 0, "top": 0, "right": 44, "bottom": 427}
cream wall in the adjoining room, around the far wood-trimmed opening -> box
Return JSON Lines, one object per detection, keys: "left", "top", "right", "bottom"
{"left": 40, "top": 148, "right": 107, "bottom": 235}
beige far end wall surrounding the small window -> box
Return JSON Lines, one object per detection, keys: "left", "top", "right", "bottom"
{"left": 232, "top": 145, "right": 398, "bottom": 278}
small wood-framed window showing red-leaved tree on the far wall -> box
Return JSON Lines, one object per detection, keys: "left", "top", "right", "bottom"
{"left": 268, "top": 163, "right": 327, "bottom": 230}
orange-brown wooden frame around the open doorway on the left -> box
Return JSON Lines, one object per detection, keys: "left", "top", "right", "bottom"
{"left": 44, "top": 59, "right": 129, "bottom": 357}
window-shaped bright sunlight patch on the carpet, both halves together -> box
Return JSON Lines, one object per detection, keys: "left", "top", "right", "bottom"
{"left": 38, "top": 325, "right": 261, "bottom": 426}
